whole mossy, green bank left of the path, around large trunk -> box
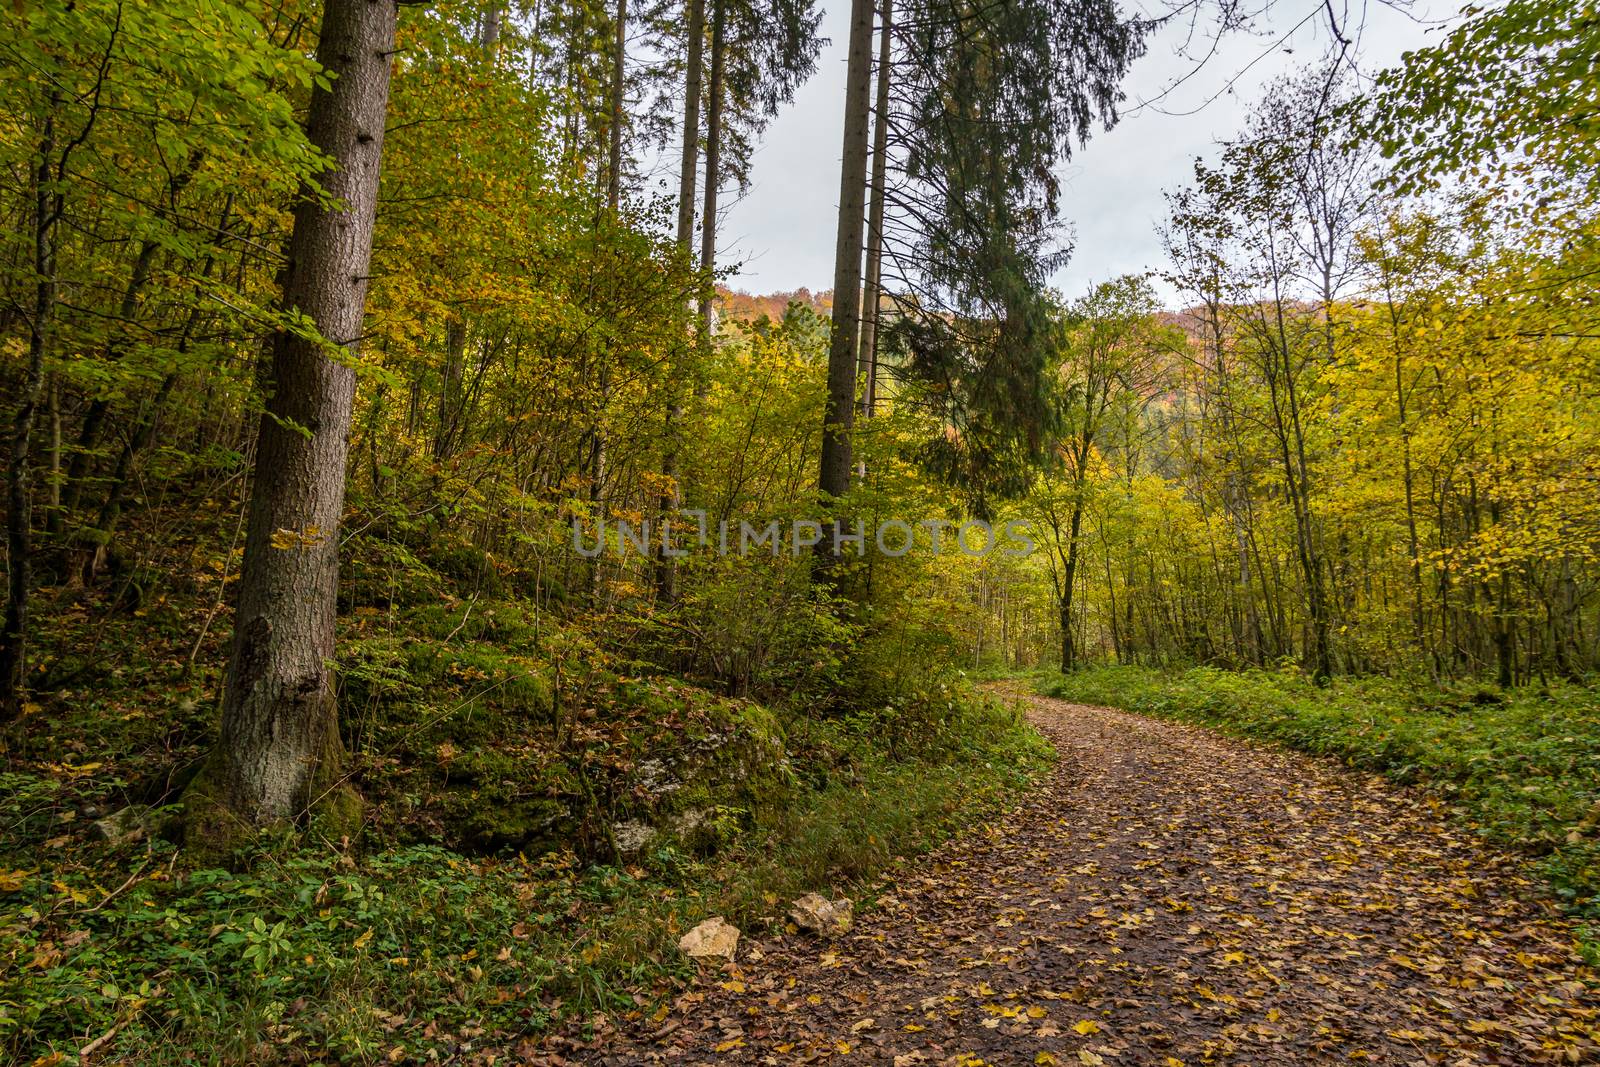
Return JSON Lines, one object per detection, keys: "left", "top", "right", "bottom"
{"left": 0, "top": 512, "right": 1050, "bottom": 1064}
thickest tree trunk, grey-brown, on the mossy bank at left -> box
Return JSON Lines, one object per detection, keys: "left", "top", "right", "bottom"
{"left": 187, "top": 0, "right": 398, "bottom": 849}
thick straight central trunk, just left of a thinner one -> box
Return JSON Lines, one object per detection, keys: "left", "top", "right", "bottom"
{"left": 818, "top": 0, "right": 872, "bottom": 547}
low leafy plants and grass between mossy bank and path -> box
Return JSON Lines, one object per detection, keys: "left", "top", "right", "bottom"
{"left": 0, "top": 691, "right": 1048, "bottom": 1064}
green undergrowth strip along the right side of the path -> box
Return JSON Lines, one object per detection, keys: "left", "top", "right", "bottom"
{"left": 1037, "top": 667, "right": 1600, "bottom": 955}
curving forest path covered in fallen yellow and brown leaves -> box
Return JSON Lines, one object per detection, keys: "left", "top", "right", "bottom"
{"left": 589, "top": 693, "right": 1600, "bottom": 1065}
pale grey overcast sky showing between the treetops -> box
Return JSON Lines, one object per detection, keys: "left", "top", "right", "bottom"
{"left": 717, "top": 0, "right": 1456, "bottom": 296}
